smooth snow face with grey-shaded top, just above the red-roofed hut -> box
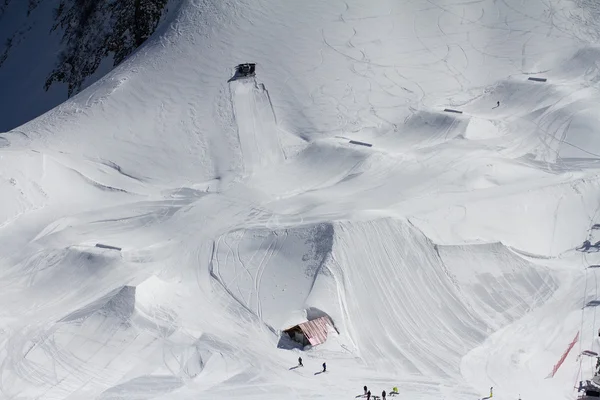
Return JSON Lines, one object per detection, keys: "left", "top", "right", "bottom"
{"left": 211, "top": 224, "right": 333, "bottom": 330}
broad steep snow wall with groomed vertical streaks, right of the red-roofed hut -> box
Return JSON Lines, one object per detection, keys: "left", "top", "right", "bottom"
{"left": 330, "top": 219, "right": 557, "bottom": 379}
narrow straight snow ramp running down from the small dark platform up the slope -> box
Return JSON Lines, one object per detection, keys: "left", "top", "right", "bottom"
{"left": 229, "top": 69, "right": 283, "bottom": 175}
